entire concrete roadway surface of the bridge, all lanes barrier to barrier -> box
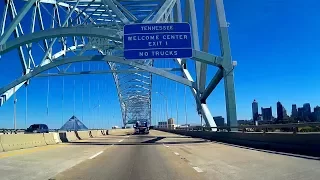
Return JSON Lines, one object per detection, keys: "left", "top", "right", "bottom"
{"left": 0, "top": 131, "right": 320, "bottom": 180}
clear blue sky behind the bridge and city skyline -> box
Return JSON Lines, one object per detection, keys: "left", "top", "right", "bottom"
{"left": 0, "top": 0, "right": 320, "bottom": 128}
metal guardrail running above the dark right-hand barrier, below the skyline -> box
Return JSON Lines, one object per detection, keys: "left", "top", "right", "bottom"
{"left": 176, "top": 122, "right": 320, "bottom": 134}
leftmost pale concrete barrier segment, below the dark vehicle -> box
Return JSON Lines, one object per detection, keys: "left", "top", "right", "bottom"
{"left": 0, "top": 134, "right": 47, "bottom": 151}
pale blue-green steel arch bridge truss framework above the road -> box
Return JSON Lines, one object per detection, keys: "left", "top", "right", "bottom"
{"left": 0, "top": 0, "right": 237, "bottom": 127}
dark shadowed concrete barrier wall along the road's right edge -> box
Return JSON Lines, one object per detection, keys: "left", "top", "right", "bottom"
{"left": 160, "top": 129, "right": 320, "bottom": 157}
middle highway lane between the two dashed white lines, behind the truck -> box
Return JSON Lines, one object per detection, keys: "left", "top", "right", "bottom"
{"left": 51, "top": 133, "right": 204, "bottom": 180}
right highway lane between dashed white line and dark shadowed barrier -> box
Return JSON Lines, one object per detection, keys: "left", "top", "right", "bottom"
{"left": 153, "top": 131, "right": 320, "bottom": 180}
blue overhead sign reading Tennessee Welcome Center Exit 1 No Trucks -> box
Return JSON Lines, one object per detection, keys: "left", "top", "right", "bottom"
{"left": 123, "top": 23, "right": 192, "bottom": 59}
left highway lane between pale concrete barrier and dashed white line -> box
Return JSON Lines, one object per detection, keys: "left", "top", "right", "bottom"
{"left": 0, "top": 136, "right": 126, "bottom": 180}
